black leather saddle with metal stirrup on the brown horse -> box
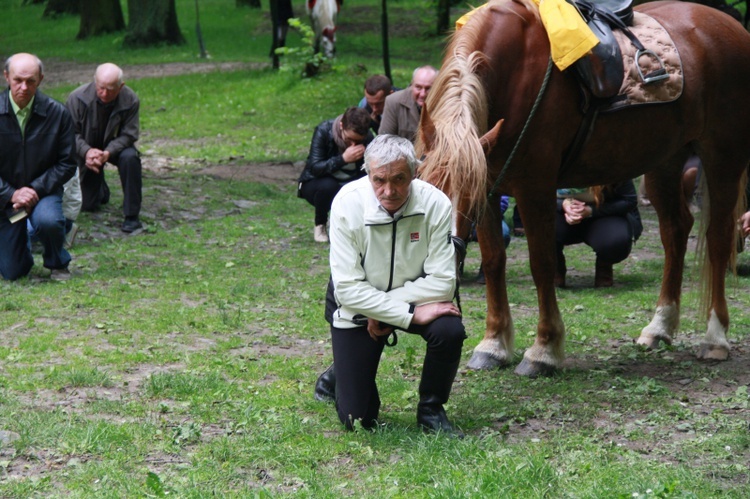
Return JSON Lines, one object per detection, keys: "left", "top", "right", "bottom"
{"left": 568, "top": 0, "right": 669, "bottom": 99}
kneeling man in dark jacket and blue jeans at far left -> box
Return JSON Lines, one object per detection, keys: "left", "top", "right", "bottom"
{"left": 0, "top": 53, "right": 76, "bottom": 280}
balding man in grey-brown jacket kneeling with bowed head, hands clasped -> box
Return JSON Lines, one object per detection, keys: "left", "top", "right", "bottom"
{"left": 67, "top": 63, "right": 143, "bottom": 232}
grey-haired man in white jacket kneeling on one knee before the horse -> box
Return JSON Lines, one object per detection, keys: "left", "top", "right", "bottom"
{"left": 315, "top": 135, "right": 466, "bottom": 433}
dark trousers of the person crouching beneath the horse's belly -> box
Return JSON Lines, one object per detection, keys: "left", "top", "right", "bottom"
{"left": 555, "top": 212, "right": 633, "bottom": 263}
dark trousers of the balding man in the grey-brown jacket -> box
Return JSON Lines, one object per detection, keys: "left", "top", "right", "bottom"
{"left": 80, "top": 147, "right": 143, "bottom": 217}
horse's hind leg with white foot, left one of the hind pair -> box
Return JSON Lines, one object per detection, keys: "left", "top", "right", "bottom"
{"left": 636, "top": 158, "right": 693, "bottom": 348}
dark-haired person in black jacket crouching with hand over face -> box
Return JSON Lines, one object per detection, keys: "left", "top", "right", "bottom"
{"left": 297, "top": 107, "right": 373, "bottom": 243}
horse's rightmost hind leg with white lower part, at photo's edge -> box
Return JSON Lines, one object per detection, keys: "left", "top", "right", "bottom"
{"left": 698, "top": 161, "right": 745, "bottom": 360}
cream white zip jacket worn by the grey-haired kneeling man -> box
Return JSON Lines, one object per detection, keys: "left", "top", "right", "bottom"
{"left": 329, "top": 177, "right": 456, "bottom": 329}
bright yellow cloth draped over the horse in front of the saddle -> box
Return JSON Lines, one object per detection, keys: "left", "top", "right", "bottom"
{"left": 456, "top": 0, "right": 599, "bottom": 71}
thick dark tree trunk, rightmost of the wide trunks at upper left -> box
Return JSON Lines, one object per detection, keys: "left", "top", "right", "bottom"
{"left": 123, "top": 0, "right": 185, "bottom": 47}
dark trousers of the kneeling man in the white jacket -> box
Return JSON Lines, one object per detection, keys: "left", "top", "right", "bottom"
{"left": 331, "top": 316, "right": 466, "bottom": 429}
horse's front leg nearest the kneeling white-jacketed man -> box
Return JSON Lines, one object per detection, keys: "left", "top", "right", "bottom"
{"left": 467, "top": 198, "right": 515, "bottom": 369}
